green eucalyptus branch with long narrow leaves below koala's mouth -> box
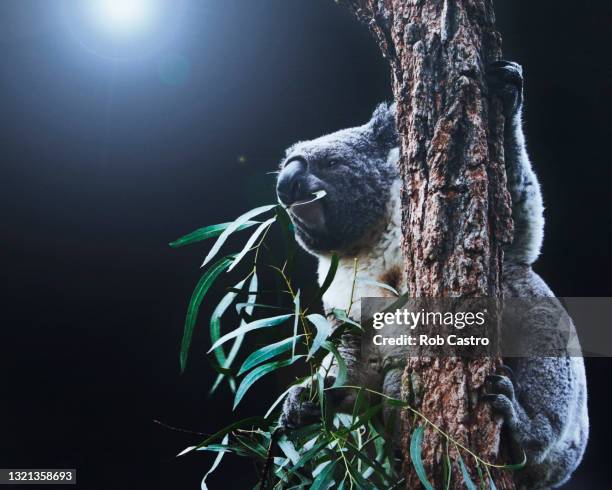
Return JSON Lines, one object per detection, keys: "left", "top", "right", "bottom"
{"left": 170, "top": 198, "right": 525, "bottom": 490}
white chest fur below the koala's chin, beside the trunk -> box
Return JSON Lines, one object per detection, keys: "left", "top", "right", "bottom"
{"left": 318, "top": 179, "right": 406, "bottom": 320}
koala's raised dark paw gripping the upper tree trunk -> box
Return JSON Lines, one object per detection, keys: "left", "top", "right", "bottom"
{"left": 487, "top": 60, "right": 523, "bottom": 117}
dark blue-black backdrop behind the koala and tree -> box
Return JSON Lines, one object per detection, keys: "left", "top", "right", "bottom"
{"left": 0, "top": 0, "right": 612, "bottom": 489}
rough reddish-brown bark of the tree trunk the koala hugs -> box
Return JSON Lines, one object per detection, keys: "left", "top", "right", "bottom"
{"left": 339, "top": 0, "right": 514, "bottom": 489}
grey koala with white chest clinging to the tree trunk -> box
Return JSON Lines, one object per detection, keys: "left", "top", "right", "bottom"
{"left": 277, "top": 61, "right": 589, "bottom": 489}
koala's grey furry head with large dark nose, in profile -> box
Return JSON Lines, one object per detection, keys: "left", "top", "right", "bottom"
{"left": 276, "top": 104, "right": 397, "bottom": 253}
